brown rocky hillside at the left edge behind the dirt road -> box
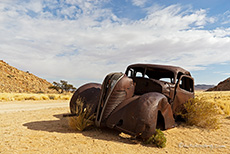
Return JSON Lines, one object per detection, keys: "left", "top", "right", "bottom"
{"left": 0, "top": 60, "right": 55, "bottom": 93}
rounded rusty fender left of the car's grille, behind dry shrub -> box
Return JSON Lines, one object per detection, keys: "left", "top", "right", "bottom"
{"left": 69, "top": 83, "right": 101, "bottom": 114}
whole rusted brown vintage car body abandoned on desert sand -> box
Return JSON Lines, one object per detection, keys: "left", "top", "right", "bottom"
{"left": 70, "top": 64, "right": 194, "bottom": 139}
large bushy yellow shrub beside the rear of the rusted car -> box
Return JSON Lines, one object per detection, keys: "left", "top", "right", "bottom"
{"left": 179, "top": 98, "right": 219, "bottom": 129}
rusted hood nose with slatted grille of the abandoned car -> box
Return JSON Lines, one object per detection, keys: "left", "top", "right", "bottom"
{"left": 96, "top": 73, "right": 134, "bottom": 126}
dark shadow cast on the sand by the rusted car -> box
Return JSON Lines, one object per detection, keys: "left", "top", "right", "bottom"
{"left": 23, "top": 114, "right": 142, "bottom": 144}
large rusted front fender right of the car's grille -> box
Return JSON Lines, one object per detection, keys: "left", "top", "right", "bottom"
{"left": 106, "top": 92, "right": 175, "bottom": 139}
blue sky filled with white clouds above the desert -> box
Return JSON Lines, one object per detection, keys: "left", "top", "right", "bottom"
{"left": 0, "top": 0, "right": 230, "bottom": 87}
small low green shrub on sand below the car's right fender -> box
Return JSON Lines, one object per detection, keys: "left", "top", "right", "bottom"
{"left": 146, "top": 129, "right": 167, "bottom": 148}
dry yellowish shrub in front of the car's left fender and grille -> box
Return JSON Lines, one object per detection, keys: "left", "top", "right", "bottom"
{"left": 69, "top": 98, "right": 95, "bottom": 131}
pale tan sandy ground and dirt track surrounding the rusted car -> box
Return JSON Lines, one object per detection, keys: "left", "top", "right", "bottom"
{"left": 0, "top": 101, "right": 230, "bottom": 154}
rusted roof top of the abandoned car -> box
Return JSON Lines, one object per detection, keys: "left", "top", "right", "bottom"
{"left": 127, "top": 64, "right": 191, "bottom": 76}
